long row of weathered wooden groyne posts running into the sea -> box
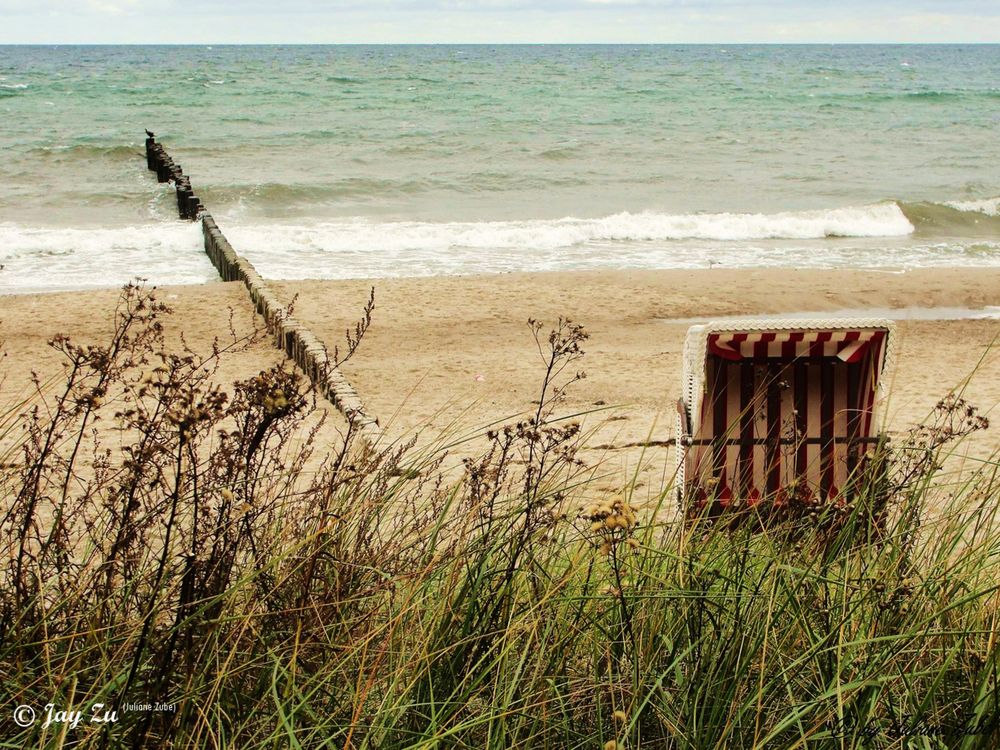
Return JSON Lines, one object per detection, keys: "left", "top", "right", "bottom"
{"left": 146, "top": 131, "right": 382, "bottom": 445}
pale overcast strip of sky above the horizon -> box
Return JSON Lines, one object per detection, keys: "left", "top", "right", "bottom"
{"left": 0, "top": 0, "right": 1000, "bottom": 44}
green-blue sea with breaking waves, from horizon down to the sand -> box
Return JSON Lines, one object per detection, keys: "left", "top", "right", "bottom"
{"left": 0, "top": 45, "right": 1000, "bottom": 293}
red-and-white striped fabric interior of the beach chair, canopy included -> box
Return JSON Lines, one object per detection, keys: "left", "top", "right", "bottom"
{"left": 685, "top": 329, "right": 886, "bottom": 506}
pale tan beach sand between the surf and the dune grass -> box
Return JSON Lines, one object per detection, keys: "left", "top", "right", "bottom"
{"left": 0, "top": 269, "right": 1000, "bottom": 500}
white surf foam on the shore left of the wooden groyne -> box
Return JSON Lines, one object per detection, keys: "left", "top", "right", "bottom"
{"left": 0, "top": 222, "right": 217, "bottom": 294}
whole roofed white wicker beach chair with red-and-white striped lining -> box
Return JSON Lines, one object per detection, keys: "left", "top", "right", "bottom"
{"left": 676, "top": 319, "right": 895, "bottom": 515}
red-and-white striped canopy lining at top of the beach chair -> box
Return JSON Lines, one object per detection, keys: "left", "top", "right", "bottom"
{"left": 708, "top": 329, "right": 886, "bottom": 362}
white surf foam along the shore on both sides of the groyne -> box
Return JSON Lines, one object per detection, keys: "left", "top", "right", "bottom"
{"left": 0, "top": 203, "right": 1000, "bottom": 294}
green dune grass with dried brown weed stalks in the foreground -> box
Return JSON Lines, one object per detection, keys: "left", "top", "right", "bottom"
{"left": 0, "top": 286, "right": 1000, "bottom": 749}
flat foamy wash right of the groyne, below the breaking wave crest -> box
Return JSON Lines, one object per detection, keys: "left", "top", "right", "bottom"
{"left": 225, "top": 223, "right": 1000, "bottom": 279}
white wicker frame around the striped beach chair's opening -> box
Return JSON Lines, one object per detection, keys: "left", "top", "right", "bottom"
{"left": 674, "top": 318, "right": 896, "bottom": 510}
